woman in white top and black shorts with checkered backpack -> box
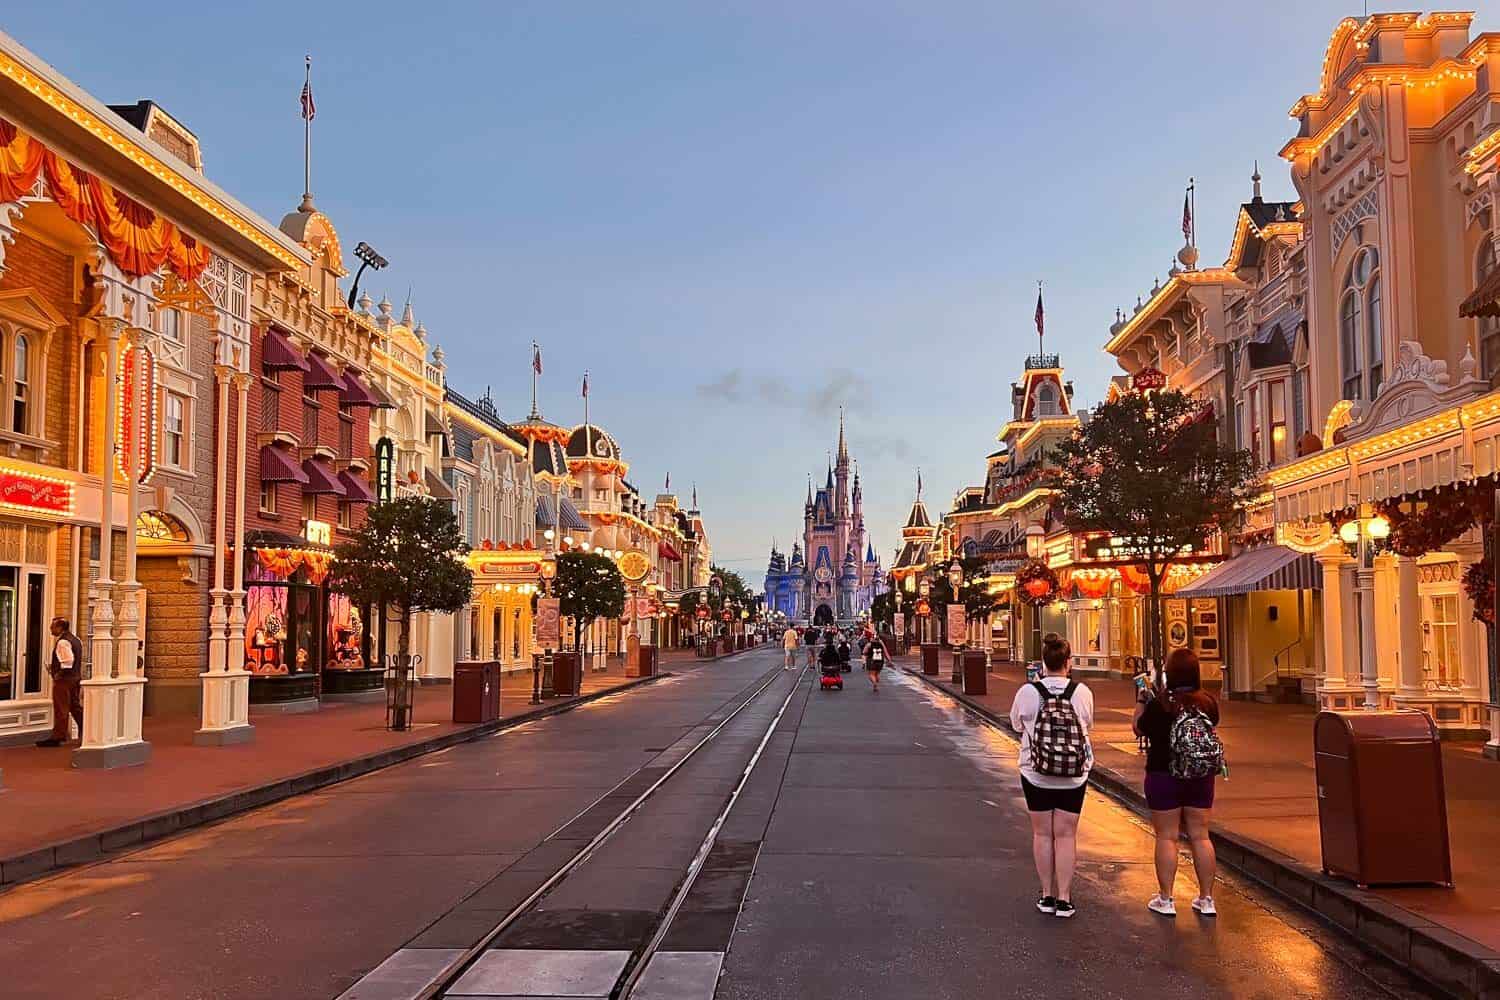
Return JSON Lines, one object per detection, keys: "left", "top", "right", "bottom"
{"left": 1011, "top": 636, "right": 1094, "bottom": 918}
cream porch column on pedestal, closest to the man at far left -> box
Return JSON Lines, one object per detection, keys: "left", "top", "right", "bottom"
{"left": 74, "top": 325, "right": 152, "bottom": 768}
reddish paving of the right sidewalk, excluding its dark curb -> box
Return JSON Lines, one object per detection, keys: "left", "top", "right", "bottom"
{"left": 897, "top": 655, "right": 1500, "bottom": 995}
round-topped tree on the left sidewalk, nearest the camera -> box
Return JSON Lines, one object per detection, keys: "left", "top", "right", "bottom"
{"left": 329, "top": 496, "right": 474, "bottom": 663}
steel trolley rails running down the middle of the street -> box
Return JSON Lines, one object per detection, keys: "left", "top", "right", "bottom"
{"left": 381, "top": 667, "right": 809, "bottom": 1000}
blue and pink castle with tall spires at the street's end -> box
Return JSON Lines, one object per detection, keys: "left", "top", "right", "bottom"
{"left": 765, "top": 414, "right": 882, "bottom": 625}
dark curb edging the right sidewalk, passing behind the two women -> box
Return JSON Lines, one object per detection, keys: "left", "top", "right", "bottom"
{"left": 902, "top": 666, "right": 1500, "bottom": 997}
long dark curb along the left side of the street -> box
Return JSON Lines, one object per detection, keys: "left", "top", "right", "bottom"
{"left": 0, "top": 672, "right": 672, "bottom": 894}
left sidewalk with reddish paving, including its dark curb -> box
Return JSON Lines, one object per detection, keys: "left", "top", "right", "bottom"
{"left": 0, "top": 663, "right": 665, "bottom": 886}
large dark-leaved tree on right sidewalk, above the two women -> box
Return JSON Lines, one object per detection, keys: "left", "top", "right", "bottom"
{"left": 1052, "top": 390, "right": 1262, "bottom": 664}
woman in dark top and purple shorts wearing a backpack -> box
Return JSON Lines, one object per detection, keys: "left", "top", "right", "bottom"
{"left": 1134, "top": 649, "right": 1224, "bottom": 916}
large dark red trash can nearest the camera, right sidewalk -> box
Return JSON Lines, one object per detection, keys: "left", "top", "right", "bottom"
{"left": 1313, "top": 709, "right": 1454, "bottom": 888}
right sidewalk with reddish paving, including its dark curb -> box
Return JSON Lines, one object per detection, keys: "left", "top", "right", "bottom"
{"left": 897, "top": 655, "right": 1500, "bottom": 993}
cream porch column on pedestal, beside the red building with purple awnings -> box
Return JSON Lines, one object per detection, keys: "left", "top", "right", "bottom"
{"left": 194, "top": 364, "right": 255, "bottom": 747}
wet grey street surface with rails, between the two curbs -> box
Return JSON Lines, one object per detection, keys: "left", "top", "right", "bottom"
{"left": 0, "top": 649, "right": 1406, "bottom": 1000}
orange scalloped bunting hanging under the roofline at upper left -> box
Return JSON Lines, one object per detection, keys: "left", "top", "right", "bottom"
{"left": 0, "top": 118, "right": 213, "bottom": 282}
